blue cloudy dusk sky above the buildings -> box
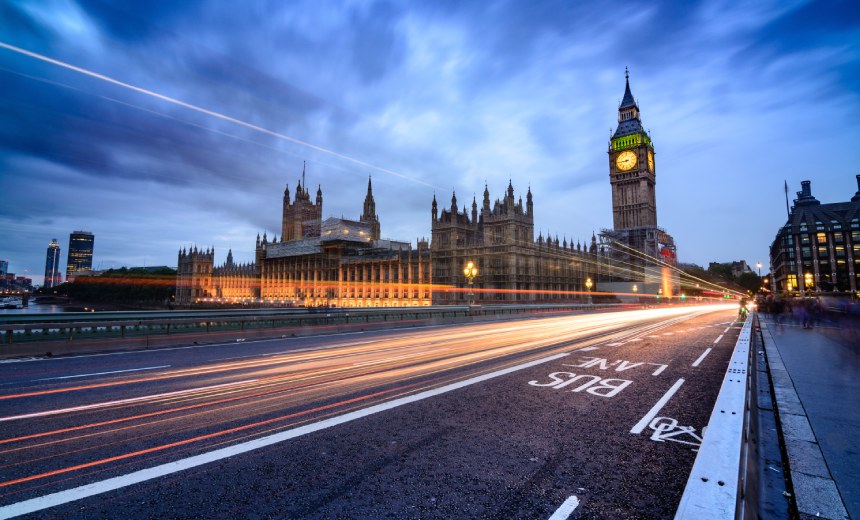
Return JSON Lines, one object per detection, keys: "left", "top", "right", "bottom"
{"left": 0, "top": 0, "right": 860, "bottom": 284}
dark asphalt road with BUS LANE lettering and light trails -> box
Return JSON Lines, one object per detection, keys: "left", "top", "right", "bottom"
{"left": 0, "top": 306, "right": 739, "bottom": 519}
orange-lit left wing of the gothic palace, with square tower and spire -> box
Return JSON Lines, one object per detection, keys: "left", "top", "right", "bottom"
{"left": 176, "top": 170, "right": 432, "bottom": 307}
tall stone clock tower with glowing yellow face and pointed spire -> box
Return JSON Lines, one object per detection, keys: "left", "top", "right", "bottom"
{"left": 609, "top": 69, "right": 657, "bottom": 230}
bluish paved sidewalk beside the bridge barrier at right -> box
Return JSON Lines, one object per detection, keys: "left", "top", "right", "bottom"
{"left": 759, "top": 314, "right": 860, "bottom": 520}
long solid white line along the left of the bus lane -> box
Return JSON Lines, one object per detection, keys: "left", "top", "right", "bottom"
{"left": 0, "top": 352, "right": 569, "bottom": 518}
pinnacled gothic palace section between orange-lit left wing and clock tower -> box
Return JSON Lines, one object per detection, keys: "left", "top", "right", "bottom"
{"left": 431, "top": 182, "right": 600, "bottom": 304}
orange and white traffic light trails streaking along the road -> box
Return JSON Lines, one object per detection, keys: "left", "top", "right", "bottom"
{"left": 0, "top": 305, "right": 734, "bottom": 508}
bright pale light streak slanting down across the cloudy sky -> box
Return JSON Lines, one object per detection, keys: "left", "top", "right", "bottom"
{"left": 0, "top": 41, "right": 430, "bottom": 188}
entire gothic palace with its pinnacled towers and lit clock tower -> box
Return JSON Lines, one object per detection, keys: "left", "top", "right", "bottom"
{"left": 176, "top": 74, "right": 678, "bottom": 307}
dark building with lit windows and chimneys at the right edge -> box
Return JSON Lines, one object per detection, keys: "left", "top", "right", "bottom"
{"left": 770, "top": 175, "right": 860, "bottom": 294}
